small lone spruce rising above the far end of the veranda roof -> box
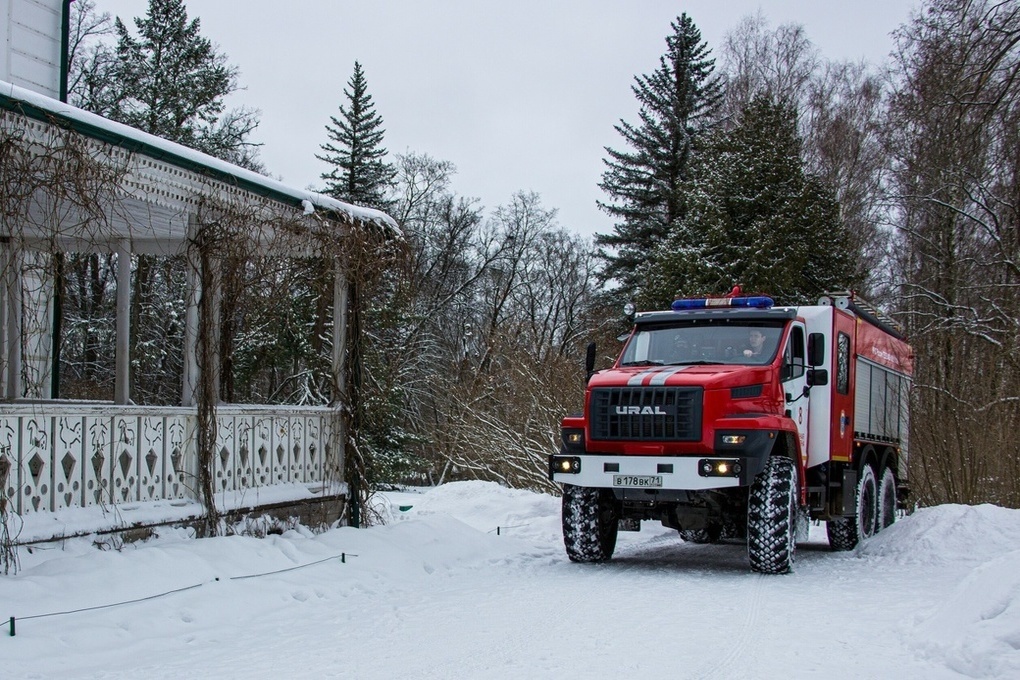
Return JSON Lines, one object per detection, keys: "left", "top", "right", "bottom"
{"left": 315, "top": 61, "right": 396, "bottom": 209}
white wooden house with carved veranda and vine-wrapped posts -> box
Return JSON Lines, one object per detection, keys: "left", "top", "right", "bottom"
{"left": 0, "top": 0, "right": 396, "bottom": 542}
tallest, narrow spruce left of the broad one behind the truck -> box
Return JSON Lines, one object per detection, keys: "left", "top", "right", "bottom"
{"left": 596, "top": 14, "right": 722, "bottom": 295}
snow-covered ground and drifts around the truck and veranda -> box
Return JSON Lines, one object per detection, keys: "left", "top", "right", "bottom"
{"left": 0, "top": 482, "right": 1020, "bottom": 680}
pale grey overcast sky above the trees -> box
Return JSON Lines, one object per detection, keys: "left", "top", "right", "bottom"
{"left": 95, "top": 0, "right": 918, "bottom": 237}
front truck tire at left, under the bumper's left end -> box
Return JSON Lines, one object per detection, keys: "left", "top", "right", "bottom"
{"left": 563, "top": 484, "right": 619, "bottom": 562}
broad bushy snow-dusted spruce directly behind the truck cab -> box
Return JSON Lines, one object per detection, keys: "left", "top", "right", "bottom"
{"left": 646, "top": 96, "right": 860, "bottom": 305}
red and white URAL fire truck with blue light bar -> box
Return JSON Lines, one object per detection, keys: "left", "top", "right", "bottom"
{"left": 549, "top": 289, "right": 913, "bottom": 573}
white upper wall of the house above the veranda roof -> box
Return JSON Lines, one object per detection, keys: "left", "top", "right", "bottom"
{"left": 0, "top": 0, "right": 63, "bottom": 99}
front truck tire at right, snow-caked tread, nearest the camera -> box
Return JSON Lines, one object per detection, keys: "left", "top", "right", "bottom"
{"left": 748, "top": 456, "right": 799, "bottom": 574}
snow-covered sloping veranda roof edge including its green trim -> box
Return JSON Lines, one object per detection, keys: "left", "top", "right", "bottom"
{"left": 0, "top": 81, "right": 399, "bottom": 232}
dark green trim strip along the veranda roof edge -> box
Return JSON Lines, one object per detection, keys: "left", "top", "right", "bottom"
{"left": 0, "top": 92, "right": 344, "bottom": 221}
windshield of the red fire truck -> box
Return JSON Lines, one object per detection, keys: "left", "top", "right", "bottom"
{"left": 620, "top": 321, "right": 782, "bottom": 366}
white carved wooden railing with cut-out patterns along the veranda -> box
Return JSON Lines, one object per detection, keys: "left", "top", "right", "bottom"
{"left": 0, "top": 402, "right": 343, "bottom": 514}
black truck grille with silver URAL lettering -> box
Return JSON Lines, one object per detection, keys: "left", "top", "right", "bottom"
{"left": 590, "top": 387, "right": 703, "bottom": 441}
